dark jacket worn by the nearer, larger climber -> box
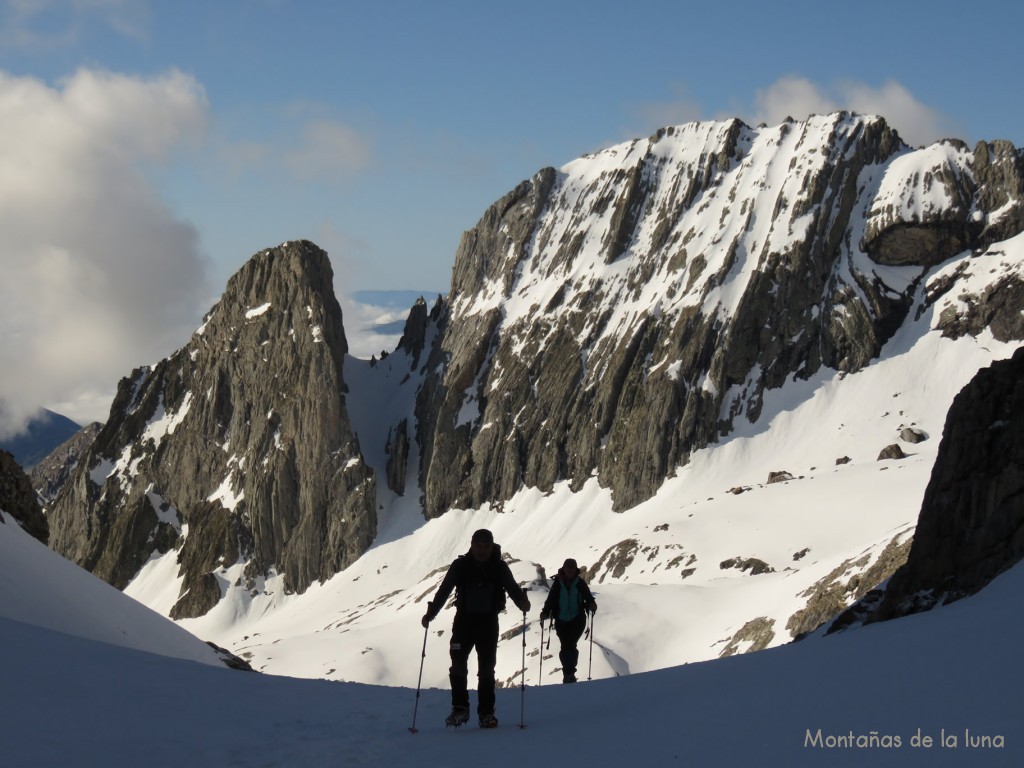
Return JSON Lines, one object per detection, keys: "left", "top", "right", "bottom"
{"left": 427, "top": 544, "right": 526, "bottom": 621}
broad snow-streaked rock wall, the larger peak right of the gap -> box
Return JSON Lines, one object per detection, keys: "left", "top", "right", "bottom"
{"left": 409, "top": 113, "right": 1024, "bottom": 516}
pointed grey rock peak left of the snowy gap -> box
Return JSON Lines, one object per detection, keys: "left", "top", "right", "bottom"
{"left": 50, "top": 242, "right": 376, "bottom": 617}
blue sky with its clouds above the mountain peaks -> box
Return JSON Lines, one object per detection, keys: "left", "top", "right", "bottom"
{"left": 0, "top": 0, "right": 1024, "bottom": 428}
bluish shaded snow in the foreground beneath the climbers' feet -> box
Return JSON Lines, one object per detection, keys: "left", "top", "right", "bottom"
{"left": 0, "top": 501, "right": 1024, "bottom": 768}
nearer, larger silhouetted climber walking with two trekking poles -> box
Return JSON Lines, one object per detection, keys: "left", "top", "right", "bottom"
{"left": 422, "top": 528, "right": 529, "bottom": 728}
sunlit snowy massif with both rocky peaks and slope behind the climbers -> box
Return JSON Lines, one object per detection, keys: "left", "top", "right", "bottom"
{"left": 39, "top": 113, "right": 1024, "bottom": 686}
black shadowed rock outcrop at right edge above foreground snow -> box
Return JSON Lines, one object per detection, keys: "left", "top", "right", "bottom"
{"left": 874, "top": 347, "right": 1024, "bottom": 620}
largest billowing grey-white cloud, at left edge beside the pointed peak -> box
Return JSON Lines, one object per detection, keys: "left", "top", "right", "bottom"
{"left": 0, "top": 70, "right": 209, "bottom": 432}
